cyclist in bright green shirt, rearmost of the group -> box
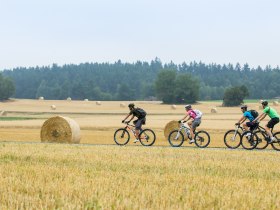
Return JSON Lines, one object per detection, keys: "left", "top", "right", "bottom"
{"left": 254, "top": 101, "right": 279, "bottom": 143}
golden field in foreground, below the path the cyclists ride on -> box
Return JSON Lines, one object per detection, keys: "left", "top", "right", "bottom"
{"left": 0, "top": 143, "right": 280, "bottom": 209}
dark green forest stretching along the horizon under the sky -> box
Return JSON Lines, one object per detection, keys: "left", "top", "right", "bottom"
{"left": 0, "top": 58, "right": 280, "bottom": 103}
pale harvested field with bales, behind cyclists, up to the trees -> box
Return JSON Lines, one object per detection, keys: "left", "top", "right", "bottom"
{"left": 0, "top": 100, "right": 280, "bottom": 147}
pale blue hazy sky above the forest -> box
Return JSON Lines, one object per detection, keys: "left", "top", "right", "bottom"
{"left": 0, "top": 0, "right": 280, "bottom": 70}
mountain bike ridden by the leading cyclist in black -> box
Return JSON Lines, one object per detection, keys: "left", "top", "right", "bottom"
{"left": 114, "top": 122, "right": 156, "bottom": 146}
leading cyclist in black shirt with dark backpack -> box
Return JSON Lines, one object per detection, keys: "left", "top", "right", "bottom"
{"left": 122, "top": 103, "right": 147, "bottom": 143}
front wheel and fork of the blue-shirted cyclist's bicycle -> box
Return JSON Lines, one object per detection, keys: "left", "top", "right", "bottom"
{"left": 224, "top": 125, "right": 244, "bottom": 149}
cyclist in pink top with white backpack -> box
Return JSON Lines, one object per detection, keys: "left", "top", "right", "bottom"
{"left": 178, "top": 104, "right": 202, "bottom": 144}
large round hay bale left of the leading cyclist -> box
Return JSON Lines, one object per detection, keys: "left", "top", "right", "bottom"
{"left": 41, "top": 116, "right": 81, "bottom": 144}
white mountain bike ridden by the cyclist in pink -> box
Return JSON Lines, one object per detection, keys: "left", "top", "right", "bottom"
{"left": 168, "top": 121, "right": 210, "bottom": 148}
